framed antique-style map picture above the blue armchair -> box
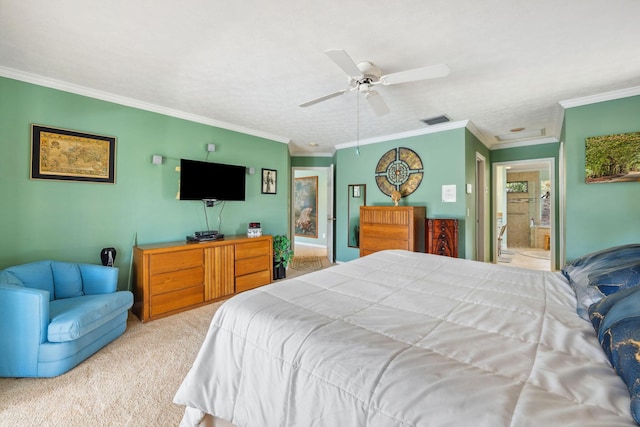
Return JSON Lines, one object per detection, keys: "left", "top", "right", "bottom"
{"left": 31, "top": 125, "right": 116, "bottom": 184}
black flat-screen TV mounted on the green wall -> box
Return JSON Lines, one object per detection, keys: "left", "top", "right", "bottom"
{"left": 180, "top": 159, "right": 246, "bottom": 201}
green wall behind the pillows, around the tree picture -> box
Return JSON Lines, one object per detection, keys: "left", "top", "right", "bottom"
{"left": 564, "top": 96, "right": 640, "bottom": 261}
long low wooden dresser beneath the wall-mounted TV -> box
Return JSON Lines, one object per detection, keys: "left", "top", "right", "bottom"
{"left": 133, "top": 236, "right": 273, "bottom": 322}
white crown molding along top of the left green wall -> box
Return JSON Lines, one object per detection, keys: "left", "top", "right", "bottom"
{"left": 0, "top": 66, "right": 291, "bottom": 144}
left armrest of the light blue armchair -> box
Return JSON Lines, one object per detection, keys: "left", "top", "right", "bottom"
{"left": 0, "top": 283, "right": 49, "bottom": 377}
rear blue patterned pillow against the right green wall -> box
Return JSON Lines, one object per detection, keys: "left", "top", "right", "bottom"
{"left": 562, "top": 244, "right": 640, "bottom": 320}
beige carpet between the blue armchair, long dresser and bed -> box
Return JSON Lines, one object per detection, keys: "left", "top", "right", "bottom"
{"left": 0, "top": 303, "right": 222, "bottom": 426}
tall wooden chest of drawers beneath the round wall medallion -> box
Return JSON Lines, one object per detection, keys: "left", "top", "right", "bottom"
{"left": 360, "top": 206, "right": 427, "bottom": 256}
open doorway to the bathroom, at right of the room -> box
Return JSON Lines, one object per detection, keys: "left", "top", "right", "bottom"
{"left": 493, "top": 158, "right": 556, "bottom": 271}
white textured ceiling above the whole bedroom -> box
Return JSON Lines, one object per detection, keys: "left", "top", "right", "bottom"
{"left": 0, "top": 0, "right": 640, "bottom": 154}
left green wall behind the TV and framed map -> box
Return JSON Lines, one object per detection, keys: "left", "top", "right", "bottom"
{"left": 0, "top": 78, "right": 290, "bottom": 288}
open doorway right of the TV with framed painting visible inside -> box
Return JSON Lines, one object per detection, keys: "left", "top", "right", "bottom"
{"left": 290, "top": 165, "right": 335, "bottom": 265}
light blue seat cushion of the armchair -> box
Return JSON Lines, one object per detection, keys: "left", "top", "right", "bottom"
{"left": 47, "top": 292, "right": 133, "bottom": 342}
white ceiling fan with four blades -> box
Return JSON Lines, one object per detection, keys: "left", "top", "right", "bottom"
{"left": 300, "top": 49, "right": 449, "bottom": 116}
